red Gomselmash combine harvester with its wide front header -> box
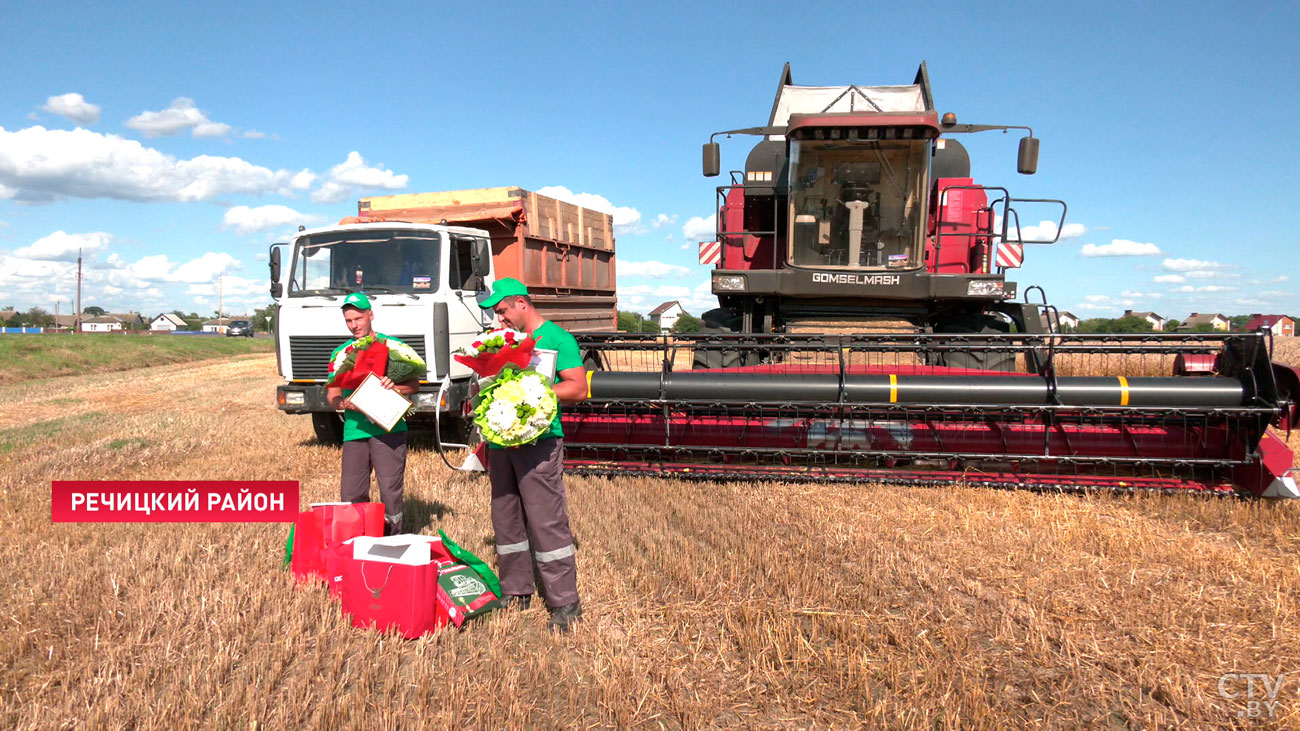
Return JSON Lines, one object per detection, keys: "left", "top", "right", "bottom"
{"left": 564, "top": 64, "right": 1300, "bottom": 497}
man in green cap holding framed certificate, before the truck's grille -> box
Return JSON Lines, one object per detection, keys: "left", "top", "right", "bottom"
{"left": 325, "top": 291, "right": 420, "bottom": 535}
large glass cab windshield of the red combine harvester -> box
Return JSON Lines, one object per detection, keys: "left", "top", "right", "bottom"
{"left": 789, "top": 139, "right": 928, "bottom": 269}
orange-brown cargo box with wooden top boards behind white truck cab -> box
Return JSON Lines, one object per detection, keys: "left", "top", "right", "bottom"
{"left": 358, "top": 187, "right": 618, "bottom": 330}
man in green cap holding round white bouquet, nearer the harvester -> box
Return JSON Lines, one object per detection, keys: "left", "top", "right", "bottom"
{"left": 480, "top": 277, "right": 588, "bottom": 632}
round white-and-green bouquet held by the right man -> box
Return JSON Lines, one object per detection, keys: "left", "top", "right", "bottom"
{"left": 473, "top": 363, "right": 559, "bottom": 446}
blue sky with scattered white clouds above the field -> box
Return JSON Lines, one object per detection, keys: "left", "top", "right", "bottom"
{"left": 0, "top": 1, "right": 1300, "bottom": 319}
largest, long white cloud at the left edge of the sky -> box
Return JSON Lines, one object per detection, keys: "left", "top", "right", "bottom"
{"left": 0, "top": 126, "right": 309, "bottom": 202}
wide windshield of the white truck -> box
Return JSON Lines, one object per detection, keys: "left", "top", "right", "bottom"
{"left": 289, "top": 229, "right": 442, "bottom": 297}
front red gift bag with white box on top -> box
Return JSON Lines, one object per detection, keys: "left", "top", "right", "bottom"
{"left": 339, "top": 535, "right": 451, "bottom": 639}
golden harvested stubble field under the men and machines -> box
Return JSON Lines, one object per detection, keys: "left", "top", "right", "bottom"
{"left": 0, "top": 343, "right": 1300, "bottom": 728}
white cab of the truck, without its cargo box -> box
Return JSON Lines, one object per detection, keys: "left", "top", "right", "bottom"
{"left": 269, "top": 221, "right": 494, "bottom": 444}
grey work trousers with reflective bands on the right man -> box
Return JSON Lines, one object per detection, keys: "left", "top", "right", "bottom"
{"left": 488, "top": 438, "right": 577, "bottom": 609}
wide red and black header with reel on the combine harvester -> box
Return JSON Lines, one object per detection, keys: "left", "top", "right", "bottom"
{"left": 563, "top": 333, "right": 1300, "bottom": 497}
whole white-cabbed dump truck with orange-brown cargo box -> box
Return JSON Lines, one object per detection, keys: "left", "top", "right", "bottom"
{"left": 269, "top": 187, "right": 618, "bottom": 444}
